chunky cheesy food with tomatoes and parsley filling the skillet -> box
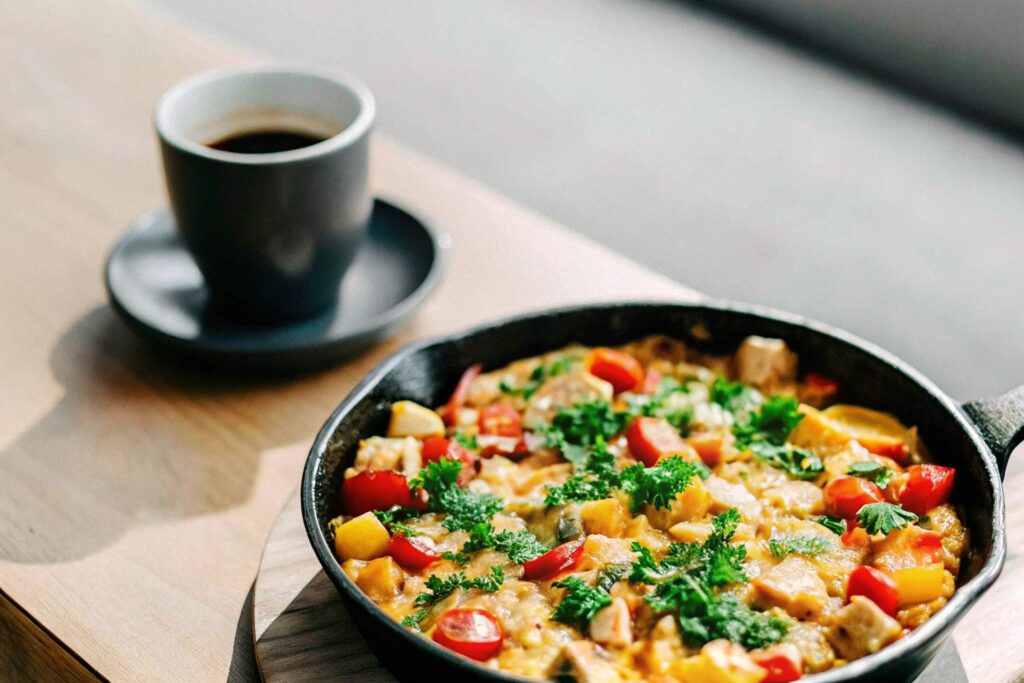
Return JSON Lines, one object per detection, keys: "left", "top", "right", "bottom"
{"left": 331, "top": 337, "right": 968, "bottom": 683}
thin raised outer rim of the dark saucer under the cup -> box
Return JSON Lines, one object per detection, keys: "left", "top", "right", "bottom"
{"left": 103, "top": 196, "right": 452, "bottom": 366}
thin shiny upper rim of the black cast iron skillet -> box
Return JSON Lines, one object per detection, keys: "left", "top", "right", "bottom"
{"left": 300, "top": 297, "right": 1007, "bottom": 683}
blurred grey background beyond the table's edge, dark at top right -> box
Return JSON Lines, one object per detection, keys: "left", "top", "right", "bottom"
{"left": 144, "top": 0, "right": 1024, "bottom": 397}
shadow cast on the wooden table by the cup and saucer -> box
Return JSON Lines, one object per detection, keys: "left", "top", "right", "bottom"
{"left": 0, "top": 306, "right": 339, "bottom": 563}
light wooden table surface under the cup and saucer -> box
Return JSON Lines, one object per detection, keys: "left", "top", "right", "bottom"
{"left": 0, "top": 0, "right": 1024, "bottom": 683}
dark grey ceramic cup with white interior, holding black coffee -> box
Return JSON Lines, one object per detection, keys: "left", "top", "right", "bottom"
{"left": 155, "top": 66, "right": 375, "bottom": 324}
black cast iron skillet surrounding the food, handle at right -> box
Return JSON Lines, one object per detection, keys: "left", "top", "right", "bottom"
{"left": 302, "top": 303, "right": 1024, "bottom": 683}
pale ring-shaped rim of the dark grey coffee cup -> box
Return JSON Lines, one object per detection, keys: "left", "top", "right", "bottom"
{"left": 153, "top": 62, "right": 377, "bottom": 166}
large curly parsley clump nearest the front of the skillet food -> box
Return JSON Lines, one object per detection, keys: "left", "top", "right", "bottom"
{"left": 630, "top": 508, "right": 788, "bottom": 649}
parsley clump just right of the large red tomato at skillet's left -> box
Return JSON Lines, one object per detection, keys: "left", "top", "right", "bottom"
{"left": 409, "top": 458, "right": 505, "bottom": 531}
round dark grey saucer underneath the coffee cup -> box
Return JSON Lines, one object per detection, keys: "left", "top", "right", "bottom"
{"left": 105, "top": 200, "right": 451, "bottom": 369}
